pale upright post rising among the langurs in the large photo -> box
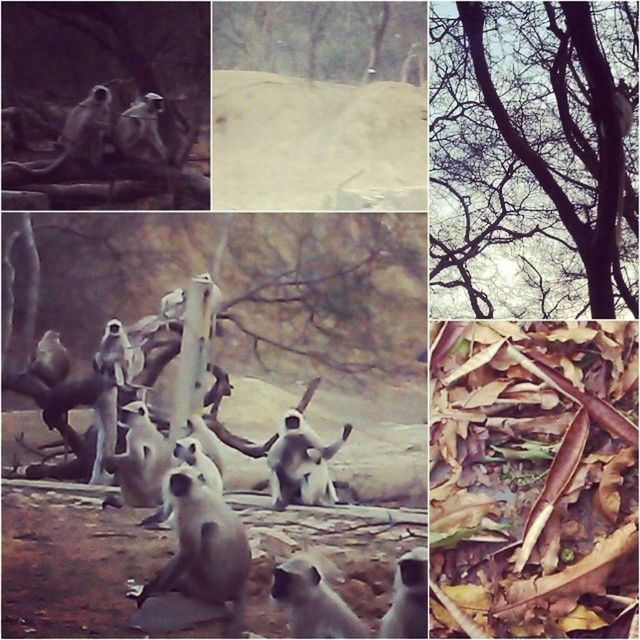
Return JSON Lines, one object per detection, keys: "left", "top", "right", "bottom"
{"left": 169, "top": 273, "right": 222, "bottom": 442}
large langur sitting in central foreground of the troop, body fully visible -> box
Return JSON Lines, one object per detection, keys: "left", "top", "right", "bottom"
{"left": 137, "top": 466, "right": 251, "bottom": 638}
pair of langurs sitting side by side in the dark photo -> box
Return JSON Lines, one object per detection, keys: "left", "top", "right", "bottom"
{"left": 4, "top": 85, "right": 169, "bottom": 175}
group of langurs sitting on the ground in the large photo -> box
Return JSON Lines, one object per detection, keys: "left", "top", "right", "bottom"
{"left": 98, "top": 390, "right": 427, "bottom": 638}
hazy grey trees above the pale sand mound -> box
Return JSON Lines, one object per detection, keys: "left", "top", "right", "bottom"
{"left": 213, "top": 2, "right": 427, "bottom": 83}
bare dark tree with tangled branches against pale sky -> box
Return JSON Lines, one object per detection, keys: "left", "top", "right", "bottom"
{"left": 430, "top": 2, "right": 638, "bottom": 318}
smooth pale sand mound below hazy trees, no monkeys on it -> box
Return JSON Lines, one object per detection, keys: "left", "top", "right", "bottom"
{"left": 213, "top": 71, "right": 427, "bottom": 211}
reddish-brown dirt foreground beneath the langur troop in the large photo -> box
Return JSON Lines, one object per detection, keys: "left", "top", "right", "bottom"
{"left": 2, "top": 486, "right": 426, "bottom": 638}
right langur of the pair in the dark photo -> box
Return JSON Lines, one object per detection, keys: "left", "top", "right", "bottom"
{"left": 114, "top": 93, "right": 169, "bottom": 162}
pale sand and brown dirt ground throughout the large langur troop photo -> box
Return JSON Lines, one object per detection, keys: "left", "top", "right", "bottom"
{"left": 2, "top": 378, "right": 427, "bottom": 638}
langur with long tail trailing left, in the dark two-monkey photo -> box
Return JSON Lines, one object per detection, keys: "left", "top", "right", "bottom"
{"left": 4, "top": 84, "right": 111, "bottom": 176}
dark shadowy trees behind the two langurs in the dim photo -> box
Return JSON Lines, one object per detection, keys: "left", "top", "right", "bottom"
{"left": 2, "top": 2, "right": 210, "bottom": 104}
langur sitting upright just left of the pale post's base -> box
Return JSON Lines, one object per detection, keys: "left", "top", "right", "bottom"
{"left": 105, "top": 400, "right": 171, "bottom": 507}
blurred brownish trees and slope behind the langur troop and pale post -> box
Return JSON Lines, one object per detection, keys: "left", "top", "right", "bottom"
{"left": 2, "top": 213, "right": 426, "bottom": 374}
